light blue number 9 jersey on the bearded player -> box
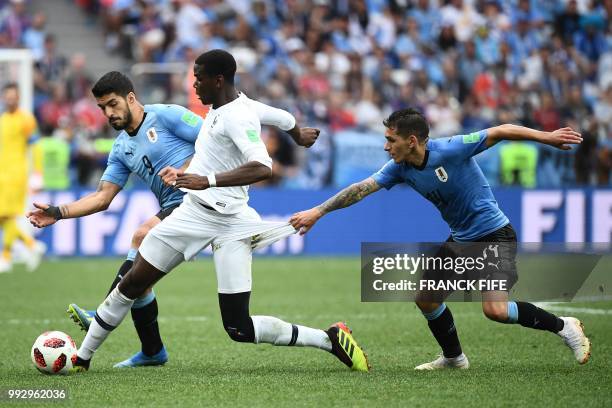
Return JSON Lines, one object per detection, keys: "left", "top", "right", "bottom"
{"left": 101, "top": 104, "right": 203, "bottom": 209}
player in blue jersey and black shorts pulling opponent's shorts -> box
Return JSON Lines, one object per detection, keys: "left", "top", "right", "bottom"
{"left": 290, "top": 109, "right": 591, "bottom": 370}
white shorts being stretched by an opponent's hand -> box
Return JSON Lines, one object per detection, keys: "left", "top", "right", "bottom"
{"left": 139, "top": 194, "right": 296, "bottom": 293}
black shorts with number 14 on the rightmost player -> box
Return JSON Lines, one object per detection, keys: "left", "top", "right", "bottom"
{"left": 419, "top": 224, "right": 518, "bottom": 302}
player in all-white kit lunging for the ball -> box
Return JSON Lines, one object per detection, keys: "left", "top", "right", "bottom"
{"left": 74, "top": 50, "right": 369, "bottom": 372}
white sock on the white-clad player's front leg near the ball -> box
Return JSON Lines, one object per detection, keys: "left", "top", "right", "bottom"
{"left": 77, "top": 288, "right": 134, "bottom": 360}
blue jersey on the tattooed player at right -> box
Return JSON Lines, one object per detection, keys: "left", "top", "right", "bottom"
{"left": 372, "top": 130, "right": 509, "bottom": 241}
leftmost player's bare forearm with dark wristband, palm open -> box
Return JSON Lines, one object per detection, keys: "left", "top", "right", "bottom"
{"left": 26, "top": 181, "right": 121, "bottom": 228}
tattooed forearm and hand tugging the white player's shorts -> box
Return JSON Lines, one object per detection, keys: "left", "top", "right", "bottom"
{"left": 289, "top": 177, "right": 381, "bottom": 235}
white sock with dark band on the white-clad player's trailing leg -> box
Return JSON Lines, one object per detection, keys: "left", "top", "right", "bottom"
{"left": 251, "top": 316, "right": 331, "bottom": 351}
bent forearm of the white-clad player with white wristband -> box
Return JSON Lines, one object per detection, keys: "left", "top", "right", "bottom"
{"left": 174, "top": 161, "right": 272, "bottom": 190}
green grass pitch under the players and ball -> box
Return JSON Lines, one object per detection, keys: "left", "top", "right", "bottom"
{"left": 0, "top": 258, "right": 612, "bottom": 407}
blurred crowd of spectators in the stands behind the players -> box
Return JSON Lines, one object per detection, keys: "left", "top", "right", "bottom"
{"left": 0, "top": 0, "right": 612, "bottom": 188}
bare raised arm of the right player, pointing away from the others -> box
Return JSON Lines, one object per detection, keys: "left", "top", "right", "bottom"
{"left": 486, "top": 124, "right": 582, "bottom": 150}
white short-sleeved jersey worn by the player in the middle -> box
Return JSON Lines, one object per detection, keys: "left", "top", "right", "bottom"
{"left": 181, "top": 97, "right": 272, "bottom": 214}
